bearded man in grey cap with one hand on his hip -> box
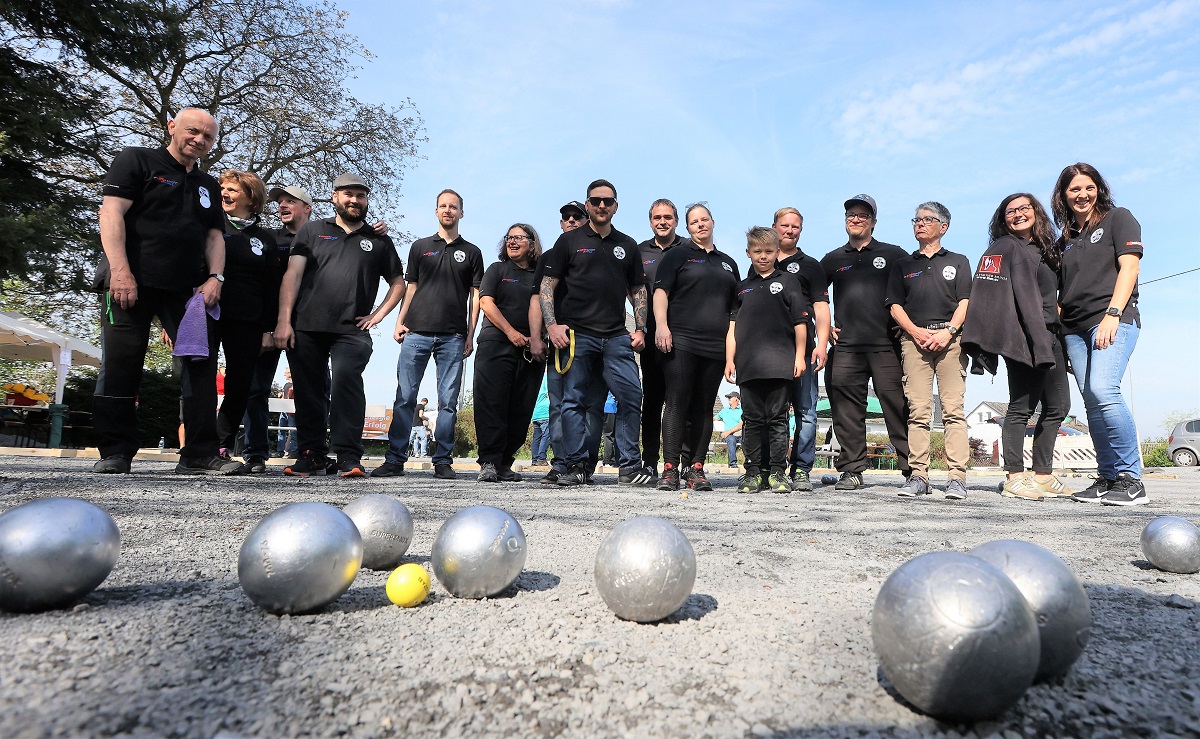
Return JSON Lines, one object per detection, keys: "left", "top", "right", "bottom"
{"left": 275, "top": 174, "right": 408, "bottom": 477}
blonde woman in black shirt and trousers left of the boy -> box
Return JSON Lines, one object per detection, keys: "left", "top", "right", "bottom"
{"left": 654, "top": 204, "right": 738, "bottom": 491}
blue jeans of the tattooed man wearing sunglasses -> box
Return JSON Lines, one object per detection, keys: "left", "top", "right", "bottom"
{"left": 562, "top": 331, "right": 642, "bottom": 470}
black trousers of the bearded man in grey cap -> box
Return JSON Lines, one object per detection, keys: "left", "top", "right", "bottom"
{"left": 288, "top": 331, "right": 372, "bottom": 461}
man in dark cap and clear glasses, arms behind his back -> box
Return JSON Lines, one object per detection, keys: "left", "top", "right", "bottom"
{"left": 821, "top": 194, "right": 908, "bottom": 491}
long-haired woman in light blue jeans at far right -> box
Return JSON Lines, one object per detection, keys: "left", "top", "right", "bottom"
{"left": 1050, "top": 163, "right": 1148, "bottom": 505}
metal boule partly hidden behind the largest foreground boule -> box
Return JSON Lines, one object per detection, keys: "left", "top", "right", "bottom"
{"left": 967, "top": 539, "right": 1092, "bottom": 680}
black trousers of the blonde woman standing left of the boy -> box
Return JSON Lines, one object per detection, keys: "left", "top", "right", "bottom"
{"left": 659, "top": 349, "right": 725, "bottom": 467}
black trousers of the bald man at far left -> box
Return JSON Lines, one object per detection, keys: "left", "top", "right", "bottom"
{"left": 92, "top": 287, "right": 217, "bottom": 457}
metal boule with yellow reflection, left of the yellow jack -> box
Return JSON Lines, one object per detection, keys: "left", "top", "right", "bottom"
{"left": 238, "top": 503, "right": 362, "bottom": 613}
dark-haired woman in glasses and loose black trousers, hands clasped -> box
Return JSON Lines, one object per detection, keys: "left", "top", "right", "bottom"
{"left": 474, "top": 223, "right": 546, "bottom": 482}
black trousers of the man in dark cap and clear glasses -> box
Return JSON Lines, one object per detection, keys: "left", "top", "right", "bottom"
{"left": 826, "top": 348, "right": 910, "bottom": 474}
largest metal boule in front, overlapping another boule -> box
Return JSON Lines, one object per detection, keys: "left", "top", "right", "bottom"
{"left": 871, "top": 552, "right": 1040, "bottom": 723}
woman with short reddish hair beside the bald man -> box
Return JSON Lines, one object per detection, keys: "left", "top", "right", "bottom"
{"left": 209, "top": 169, "right": 286, "bottom": 465}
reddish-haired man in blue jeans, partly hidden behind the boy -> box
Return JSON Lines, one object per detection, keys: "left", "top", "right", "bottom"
{"left": 772, "top": 208, "right": 829, "bottom": 493}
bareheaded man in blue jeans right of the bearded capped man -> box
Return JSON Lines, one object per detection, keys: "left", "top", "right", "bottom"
{"left": 371, "top": 190, "right": 484, "bottom": 480}
